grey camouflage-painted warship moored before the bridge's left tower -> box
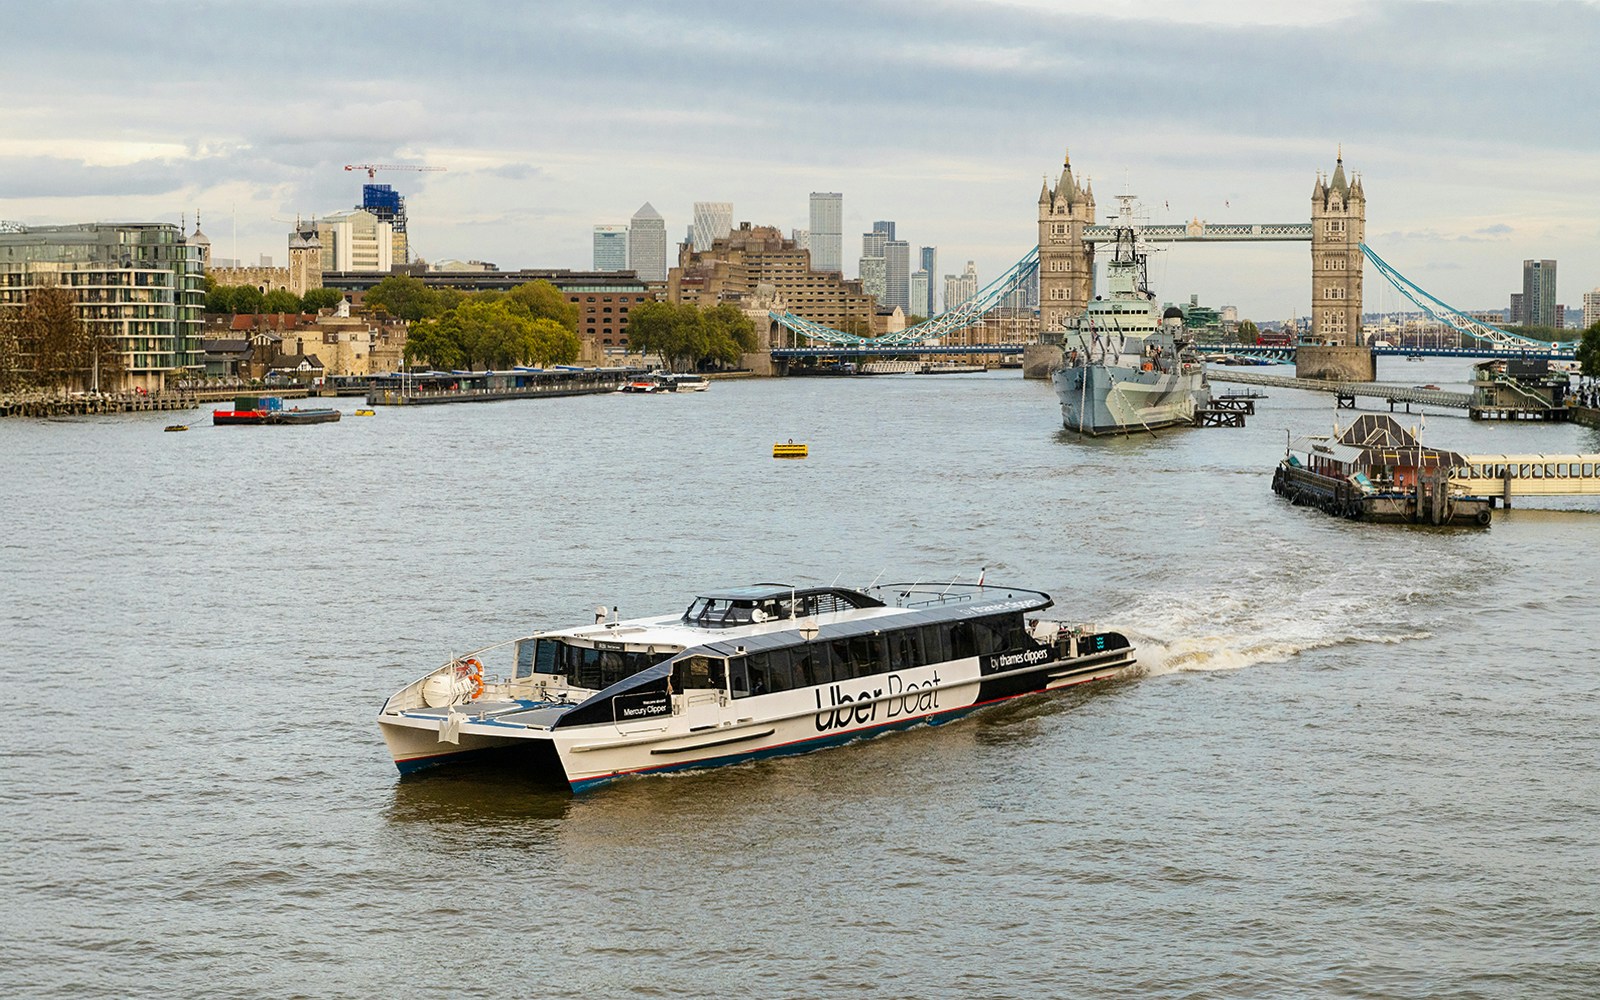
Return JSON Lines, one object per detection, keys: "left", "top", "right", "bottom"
{"left": 1051, "top": 195, "right": 1211, "bottom": 437}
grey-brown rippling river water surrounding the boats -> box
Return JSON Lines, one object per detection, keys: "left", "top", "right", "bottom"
{"left": 0, "top": 360, "right": 1600, "bottom": 997}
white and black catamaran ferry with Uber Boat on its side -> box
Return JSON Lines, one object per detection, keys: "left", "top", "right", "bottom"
{"left": 378, "top": 579, "right": 1136, "bottom": 790}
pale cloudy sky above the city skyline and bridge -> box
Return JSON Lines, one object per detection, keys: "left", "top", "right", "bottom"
{"left": 0, "top": 0, "right": 1600, "bottom": 318}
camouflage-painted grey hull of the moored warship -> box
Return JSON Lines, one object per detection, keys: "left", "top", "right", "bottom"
{"left": 1051, "top": 365, "right": 1211, "bottom": 437}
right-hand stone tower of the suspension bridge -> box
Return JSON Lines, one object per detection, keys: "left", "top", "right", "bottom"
{"left": 1309, "top": 149, "right": 1366, "bottom": 346}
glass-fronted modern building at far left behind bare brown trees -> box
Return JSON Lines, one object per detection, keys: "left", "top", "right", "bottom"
{"left": 0, "top": 222, "right": 205, "bottom": 392}
